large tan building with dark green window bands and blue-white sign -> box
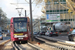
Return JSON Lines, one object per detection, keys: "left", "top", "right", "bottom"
{"left": 42, "top": 0, "right": 75, "bottom": 27}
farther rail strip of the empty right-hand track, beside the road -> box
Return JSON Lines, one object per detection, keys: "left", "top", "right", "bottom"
{"left": 40, "top": 36, "right": 75, "bottom": 48}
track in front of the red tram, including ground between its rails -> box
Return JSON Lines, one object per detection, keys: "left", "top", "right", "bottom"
{"left": 13, "top": 42, "right": 43, "bottom": 50}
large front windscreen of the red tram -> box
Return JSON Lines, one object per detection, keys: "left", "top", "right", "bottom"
{"left": 14, "top": 22, "right": 27, "bottom": 32}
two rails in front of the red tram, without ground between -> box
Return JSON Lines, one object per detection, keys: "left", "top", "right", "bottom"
{"left": 13, "top": 42, "right": 43, "bottom": 50}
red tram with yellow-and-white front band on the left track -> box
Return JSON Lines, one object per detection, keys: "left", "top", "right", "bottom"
{"left": 10, "top": 17, "right": 30, "bottom": 43}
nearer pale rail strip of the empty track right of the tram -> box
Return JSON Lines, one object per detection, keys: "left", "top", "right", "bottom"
{"left": 35, "top": 37, "right": 75, "bottom": 50}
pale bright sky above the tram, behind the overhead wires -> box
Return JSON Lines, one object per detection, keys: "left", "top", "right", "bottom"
{"left": 0, "top": 0, "right": 42, "bottom": 19}
